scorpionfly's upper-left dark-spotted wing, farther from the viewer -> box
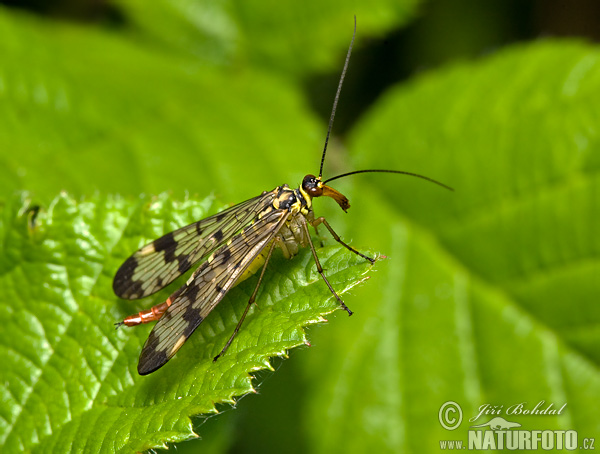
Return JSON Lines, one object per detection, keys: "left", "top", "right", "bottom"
{"left": 113, "top": 191, "right": 274, "bottom": 299}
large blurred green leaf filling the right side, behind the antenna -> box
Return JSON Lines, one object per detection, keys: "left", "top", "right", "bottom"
{"left": 294, "top": 41, "right": 600, "bottom": 453}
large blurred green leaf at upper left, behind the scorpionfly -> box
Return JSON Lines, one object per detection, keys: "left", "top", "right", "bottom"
{"left": 0, "top": 9, "right": 325, "bottom": 203}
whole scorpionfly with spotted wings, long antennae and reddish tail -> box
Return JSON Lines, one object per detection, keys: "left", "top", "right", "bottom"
{"left": 113, "top": 17, "right": 450, "bottom": 375}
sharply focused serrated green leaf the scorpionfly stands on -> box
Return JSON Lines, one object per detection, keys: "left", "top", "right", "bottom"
{"left": 0, "top": 191, "right": 370, "bottom": 453}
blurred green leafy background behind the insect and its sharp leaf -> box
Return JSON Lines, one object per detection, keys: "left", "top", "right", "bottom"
{"left": 0, "top": 0, "right": 600, "bottom": 453}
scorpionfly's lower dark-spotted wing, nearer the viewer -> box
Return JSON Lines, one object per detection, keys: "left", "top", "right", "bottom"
{"left": 138, "top": 210, "right": 289, "bottom": 375}
